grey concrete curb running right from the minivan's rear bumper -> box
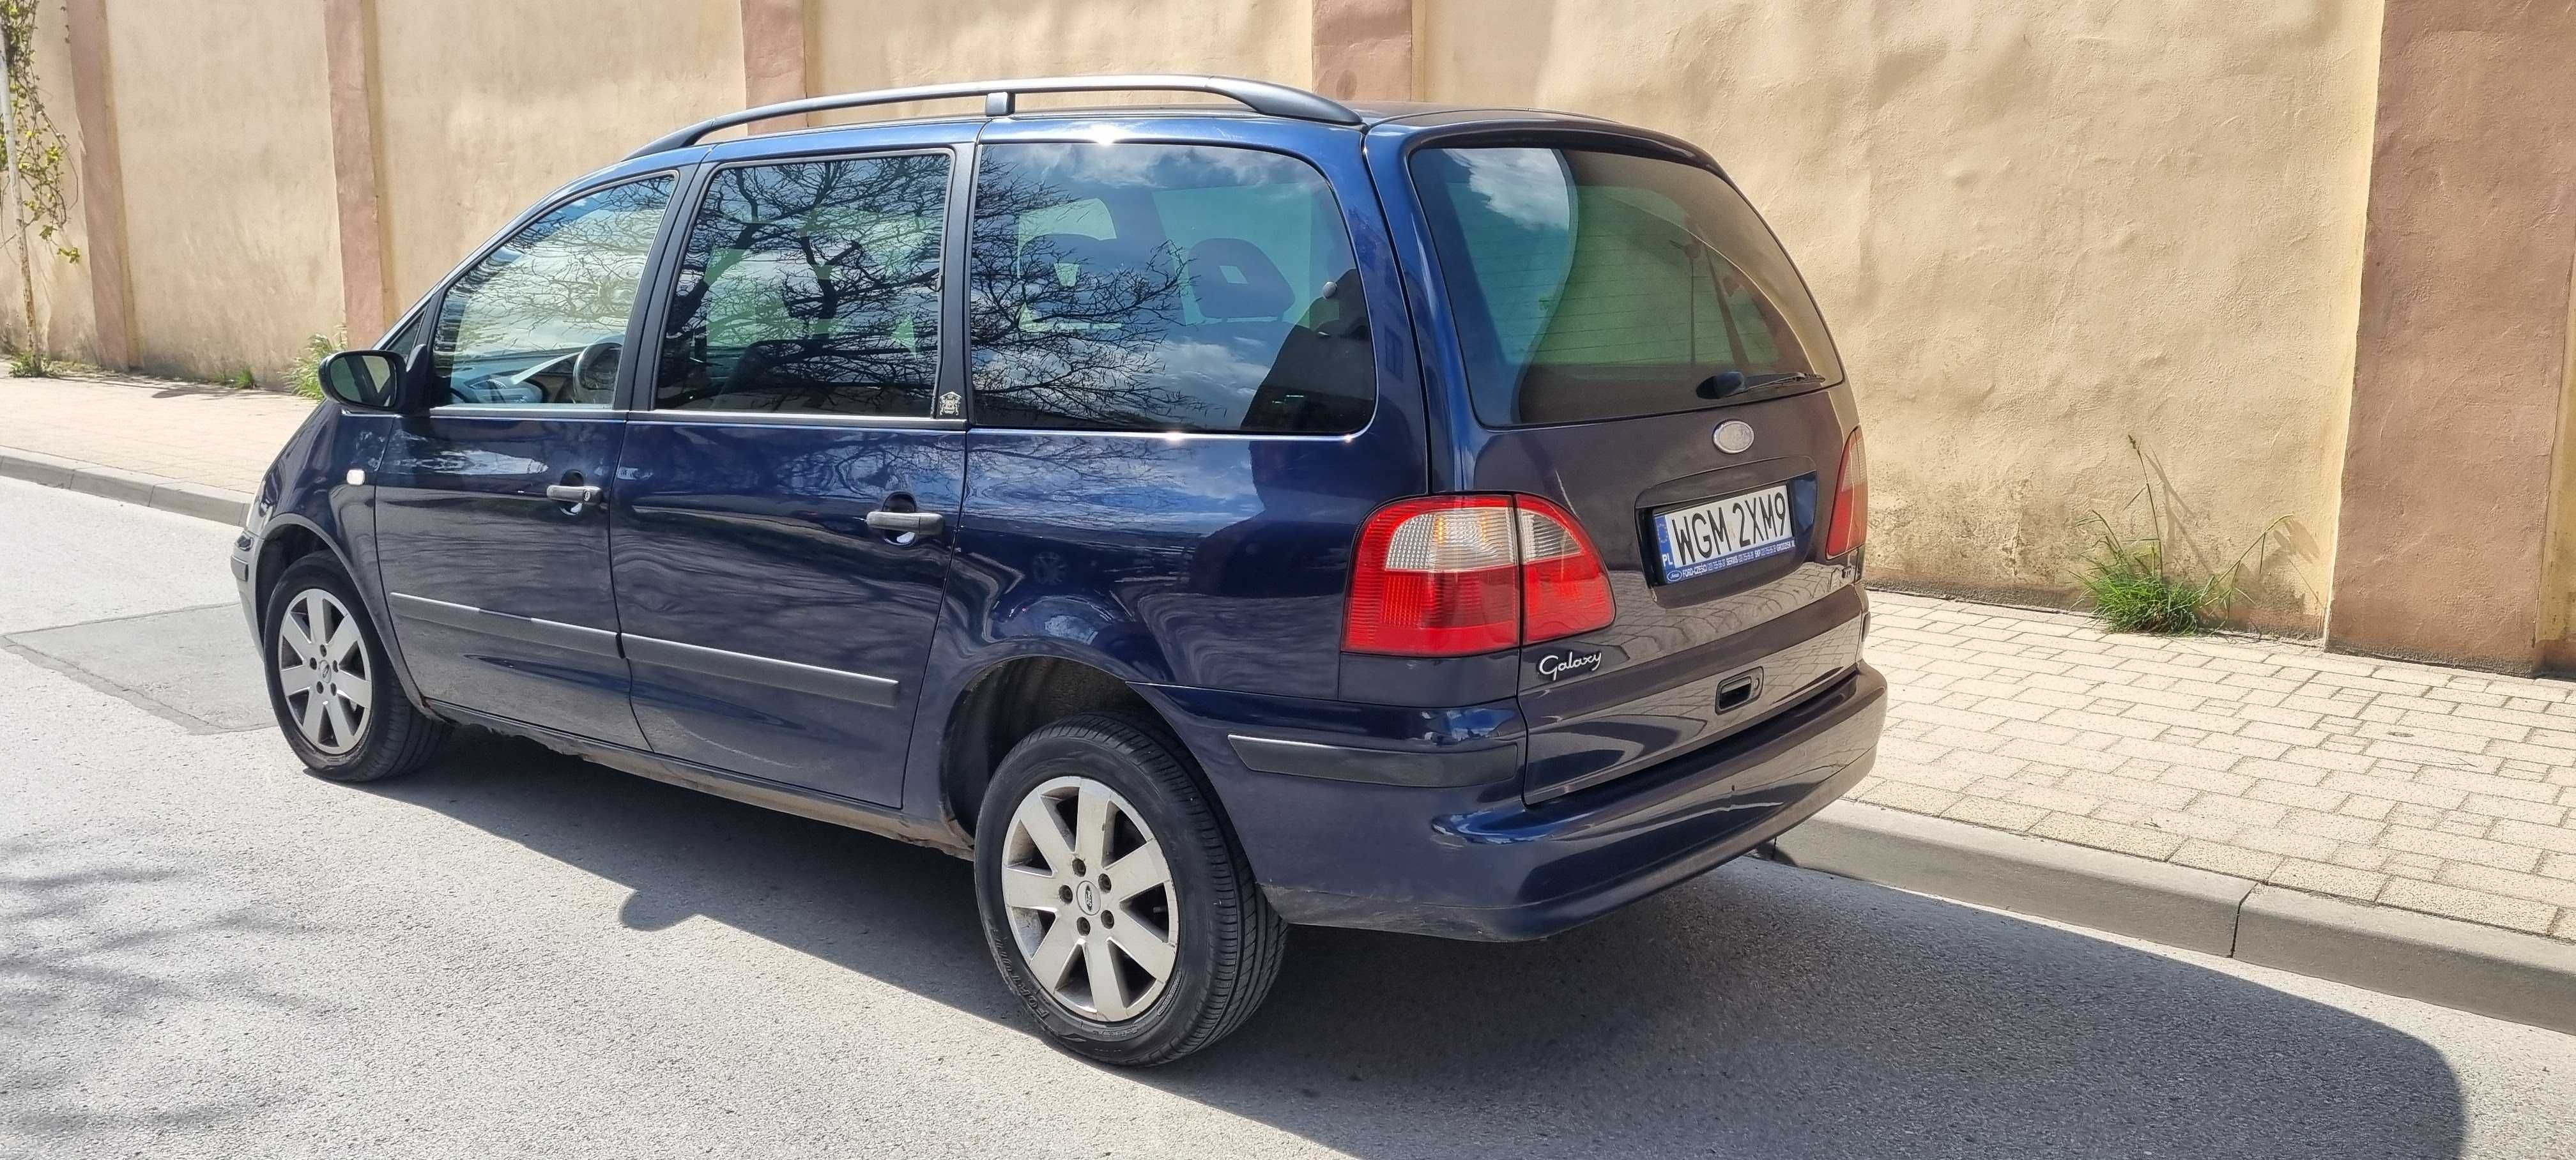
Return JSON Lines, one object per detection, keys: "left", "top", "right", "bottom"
{"left": 1777, "top": 802, "right": 2576, "bottom": 1034}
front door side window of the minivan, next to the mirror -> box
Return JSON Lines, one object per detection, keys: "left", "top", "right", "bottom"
{"left": 430, "top": 178, "right": 670, "bottom": 408}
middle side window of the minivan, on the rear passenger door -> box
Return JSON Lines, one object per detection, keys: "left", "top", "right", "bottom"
{"left": 654, "top": 155, "right": 948, "bottom": 418}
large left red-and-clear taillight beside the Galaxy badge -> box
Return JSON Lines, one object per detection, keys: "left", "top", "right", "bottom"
{"left": 1342, "top": 495, "right": 1613, "bottom": 657}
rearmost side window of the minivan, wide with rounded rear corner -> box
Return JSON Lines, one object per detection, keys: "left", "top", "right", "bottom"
{"left": 969, "top": 144, "right": 1378, "bottom": 433}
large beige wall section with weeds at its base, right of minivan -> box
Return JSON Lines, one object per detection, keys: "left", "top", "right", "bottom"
{"left": 1420, "top": 0, "right": 2378, "bottom": 629}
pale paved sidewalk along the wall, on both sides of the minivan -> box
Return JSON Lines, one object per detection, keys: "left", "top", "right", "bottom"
{"left": 15, "top": 376, "right": 2576, "bottom": 941}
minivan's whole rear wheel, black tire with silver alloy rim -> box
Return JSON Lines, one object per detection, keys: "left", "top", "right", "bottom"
{"left": 974, "top": 714, "right": 1288, "bottom": 1067}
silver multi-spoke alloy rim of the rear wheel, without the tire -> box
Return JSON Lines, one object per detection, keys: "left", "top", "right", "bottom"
{"left": 1002, "top": 776, "right": 1180, "bottom": 1023}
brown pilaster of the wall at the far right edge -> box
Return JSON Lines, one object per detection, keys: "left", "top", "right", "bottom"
{"left": 2326, "top": 0, "right": 2576, "bottom": 668}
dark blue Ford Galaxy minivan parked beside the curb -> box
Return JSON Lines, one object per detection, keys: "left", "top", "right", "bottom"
{"left": 232, "top": 75, "right": 1885, "bottom": 1065}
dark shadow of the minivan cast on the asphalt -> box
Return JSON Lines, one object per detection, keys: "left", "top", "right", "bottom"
{"left": 371, "top": 737, "right": 2463, "bottom": 1160}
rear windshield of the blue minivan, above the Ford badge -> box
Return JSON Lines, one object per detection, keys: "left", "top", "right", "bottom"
{"left": 1412, "top": 147, "right": 1842, "bottom": 425}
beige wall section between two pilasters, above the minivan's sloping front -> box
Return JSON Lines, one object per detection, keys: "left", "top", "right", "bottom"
{"left": 368, "top": 0, "right": 742, "bottom": 309}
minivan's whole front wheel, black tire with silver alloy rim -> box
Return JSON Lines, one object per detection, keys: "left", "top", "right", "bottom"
{"left": 260, "top": 552, "right": 448, "bottom": 781}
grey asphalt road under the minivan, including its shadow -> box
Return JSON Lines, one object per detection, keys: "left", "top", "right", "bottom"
{"left": 0, "top": 480, "right": 2576, "bottom": 1160}
